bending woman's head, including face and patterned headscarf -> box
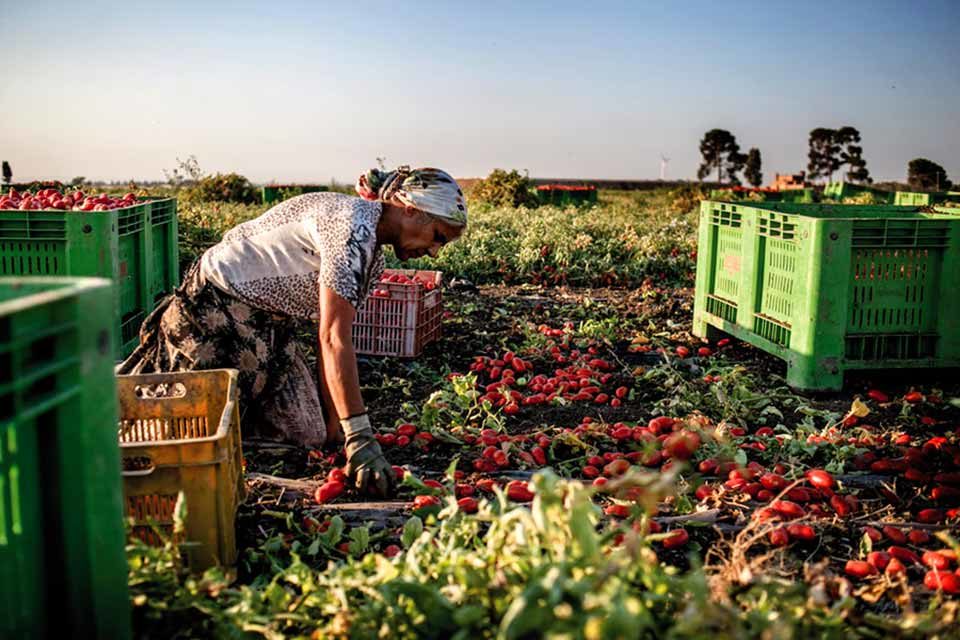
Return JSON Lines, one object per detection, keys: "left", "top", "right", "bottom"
{"left": 356, "top": 167, "right": 467, "bottom": 260}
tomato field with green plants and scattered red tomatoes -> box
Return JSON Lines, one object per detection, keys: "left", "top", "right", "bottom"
{"left": 128, "top": 188, "right": 960, "bottom": 639}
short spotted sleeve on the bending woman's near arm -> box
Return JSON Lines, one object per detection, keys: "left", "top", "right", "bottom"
{"left": 317, "top": 202, "right": 382, "bottom": 309}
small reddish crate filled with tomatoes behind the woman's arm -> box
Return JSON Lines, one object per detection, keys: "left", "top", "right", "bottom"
{"left": 353, "top": 269, "right": 443, "bottom": 358}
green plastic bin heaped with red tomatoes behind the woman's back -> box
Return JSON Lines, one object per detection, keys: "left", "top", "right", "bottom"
{"left": 0, "top": 198, "right": 180, "bottom": 358}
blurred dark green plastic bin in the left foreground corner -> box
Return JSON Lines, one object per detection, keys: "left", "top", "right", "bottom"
{"left": 0, "top": 277, "right": 130, "bottom": 638}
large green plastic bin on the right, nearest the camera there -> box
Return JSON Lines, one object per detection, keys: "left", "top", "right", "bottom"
{"left": 693, "top": 201, "right": 960, "bottom": 391}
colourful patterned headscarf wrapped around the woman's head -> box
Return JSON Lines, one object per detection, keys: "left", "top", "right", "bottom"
{"left": 356, "top": 166, "right": 467, "bottom": 227}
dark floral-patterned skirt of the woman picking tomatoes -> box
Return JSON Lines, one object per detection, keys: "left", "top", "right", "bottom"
{"left": 117, "top": 261, "right": 326, "bottom": 447}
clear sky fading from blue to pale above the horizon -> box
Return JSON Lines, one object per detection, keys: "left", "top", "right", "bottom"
{"left": 0, "top": 0, "right": 960, "bottom": 181}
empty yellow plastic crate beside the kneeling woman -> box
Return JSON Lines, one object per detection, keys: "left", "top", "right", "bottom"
{"left": 117, "top": 369, "right": 245, "bottom": 571}
